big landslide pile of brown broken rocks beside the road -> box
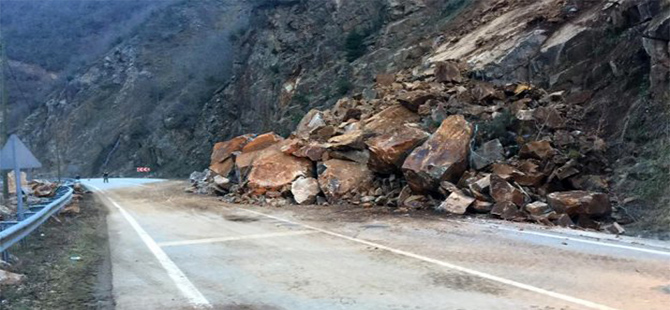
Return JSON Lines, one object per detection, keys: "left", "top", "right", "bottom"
{"left": 188, "top": 62, "right": 612, "bottom": 228}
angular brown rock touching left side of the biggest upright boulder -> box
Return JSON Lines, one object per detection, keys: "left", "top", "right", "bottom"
{"left": 366, "top": 125, "right": 430, "bottom": 173}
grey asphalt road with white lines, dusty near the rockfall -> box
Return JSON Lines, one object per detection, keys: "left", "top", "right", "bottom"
{"left": 84, "top": 179, "right": 670, "bottom": 310}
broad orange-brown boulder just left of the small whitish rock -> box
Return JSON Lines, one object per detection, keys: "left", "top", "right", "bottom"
{"left": 248, "top": 149, "right": 313, "bottom": 195}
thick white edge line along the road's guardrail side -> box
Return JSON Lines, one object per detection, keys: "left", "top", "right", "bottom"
{"left": 92, "top": 186, "right": 212, "bottom": 308}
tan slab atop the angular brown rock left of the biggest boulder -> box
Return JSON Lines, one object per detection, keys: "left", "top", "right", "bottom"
{"left": 363, "top": 105, "right": 420, "bottom": 135}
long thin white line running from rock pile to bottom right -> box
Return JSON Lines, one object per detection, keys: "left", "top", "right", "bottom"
{"left": 238, "top": 208, "right": 616, "bottom": 310}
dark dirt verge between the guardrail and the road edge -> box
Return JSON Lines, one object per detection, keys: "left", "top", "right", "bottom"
{"left": 0, "top": 194, "right": 114, "bottom": 310}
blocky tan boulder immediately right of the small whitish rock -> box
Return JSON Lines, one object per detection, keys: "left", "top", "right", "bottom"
{"left": 319, "top": 159, "right": 373, "bottom": 201}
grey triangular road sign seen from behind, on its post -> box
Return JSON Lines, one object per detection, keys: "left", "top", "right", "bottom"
{"left": 0, "top": 135, "right": 42, "bottom": 221}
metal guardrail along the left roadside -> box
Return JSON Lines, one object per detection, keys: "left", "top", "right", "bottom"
{"left": 0, "top": 186, "right": 74, "bottom": 252}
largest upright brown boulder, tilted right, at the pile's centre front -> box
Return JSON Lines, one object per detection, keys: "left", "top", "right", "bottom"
{"left": 402, "top": 115, "right": 472, "bottom": 193}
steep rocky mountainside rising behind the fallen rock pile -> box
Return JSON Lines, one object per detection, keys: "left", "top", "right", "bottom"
{"left": 19, "top": 0, "right": 670, "bottom": 235}
